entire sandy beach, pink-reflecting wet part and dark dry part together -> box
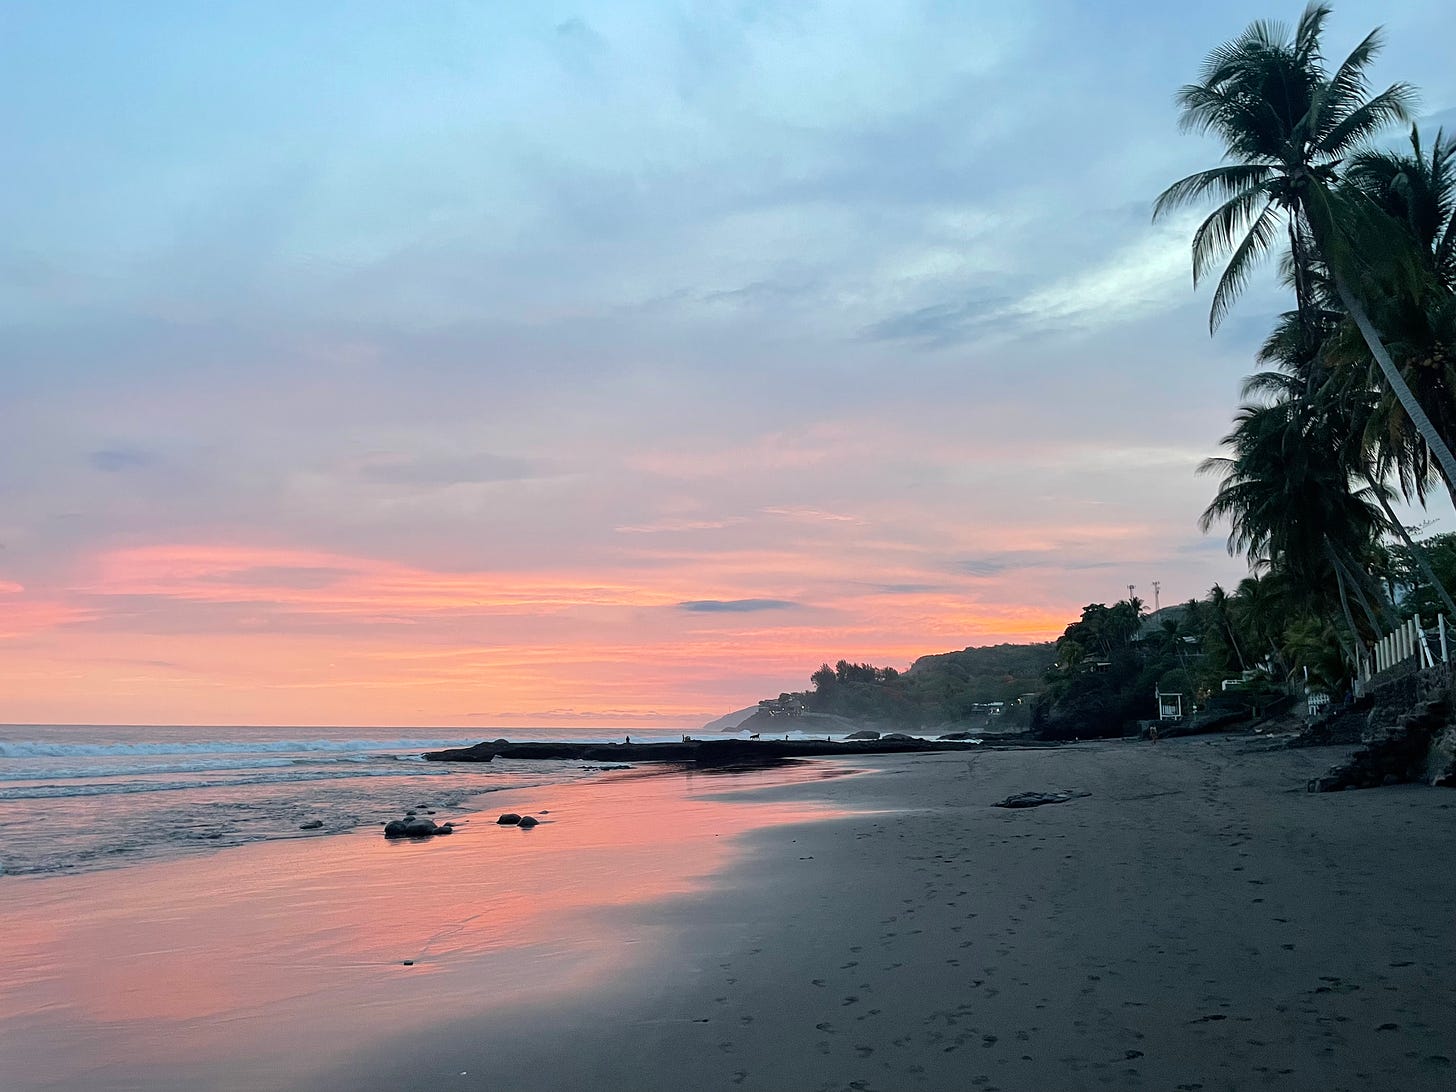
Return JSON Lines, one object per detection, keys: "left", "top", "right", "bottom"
{"left": 0, "top": 737, "right": 1456, "bottom": 1092}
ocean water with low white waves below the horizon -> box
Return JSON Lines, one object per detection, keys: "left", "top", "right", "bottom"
{"left": 0, "top": 725, "right": 728, "bottom": 875}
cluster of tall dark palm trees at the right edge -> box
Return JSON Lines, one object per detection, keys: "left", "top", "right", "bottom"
{"left": 1155, "top": 4, "right": 1456, "bottom": 693}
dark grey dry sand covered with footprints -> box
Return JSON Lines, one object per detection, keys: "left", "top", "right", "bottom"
{"left": 316, "top": 738, "right": 1456, "bottom": 1092}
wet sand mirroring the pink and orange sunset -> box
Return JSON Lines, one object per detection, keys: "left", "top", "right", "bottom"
{"left": 0, "top": 763, "right": 846, "bottom": 1092}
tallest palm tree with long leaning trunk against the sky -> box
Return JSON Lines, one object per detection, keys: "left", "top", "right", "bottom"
{"left": 1153, "top": 3, "right": 1456, "bottom": 483}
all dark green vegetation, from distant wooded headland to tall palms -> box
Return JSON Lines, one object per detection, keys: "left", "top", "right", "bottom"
{"left": 757, "top": 3, "right": 1456, "bottom": 738}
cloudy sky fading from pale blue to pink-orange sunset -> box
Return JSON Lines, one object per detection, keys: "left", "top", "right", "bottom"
{"left": 0, "top": 0, "right": 1456, "bottom": 727}
